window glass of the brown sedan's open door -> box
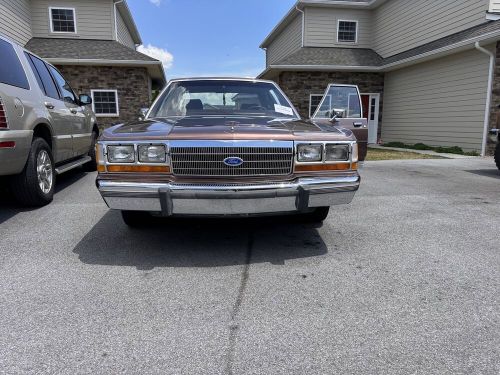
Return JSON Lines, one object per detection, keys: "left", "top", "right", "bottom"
{"left": 313, "top": 85, "right": 361, "bottom": 119}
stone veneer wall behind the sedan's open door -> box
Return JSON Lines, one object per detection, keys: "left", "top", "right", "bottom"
{"left": 277, "top": 72, "right": 384, "bottom": 139}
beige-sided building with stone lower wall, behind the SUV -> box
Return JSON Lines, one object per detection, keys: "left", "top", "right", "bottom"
{"left": 0, "top": 0, "right": 165, "bottom": 126}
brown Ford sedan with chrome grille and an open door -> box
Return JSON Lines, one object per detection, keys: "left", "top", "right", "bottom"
{"left": 97, "top": 78, "right": 366, "bottom": 226}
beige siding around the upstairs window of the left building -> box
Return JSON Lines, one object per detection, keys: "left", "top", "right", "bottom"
{"left": 31, "top": 0, "right": 115, "bottom": 40}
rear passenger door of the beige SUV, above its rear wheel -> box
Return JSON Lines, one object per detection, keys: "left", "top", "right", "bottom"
{"left": 25, "top": 52, "right": 74, "bottom": 163}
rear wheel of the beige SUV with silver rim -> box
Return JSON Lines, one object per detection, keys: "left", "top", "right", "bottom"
{"left": 11, "top": 138, "right": 56, "bottom": 207}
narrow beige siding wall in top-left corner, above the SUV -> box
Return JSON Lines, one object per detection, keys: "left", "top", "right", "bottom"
{"left": 0, "top": 0, "right": 31, "bottom": 46}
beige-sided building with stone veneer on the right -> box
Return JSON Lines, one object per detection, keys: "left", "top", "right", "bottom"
{"left": 260, "top": 0, "right": 500, "bottom": 154}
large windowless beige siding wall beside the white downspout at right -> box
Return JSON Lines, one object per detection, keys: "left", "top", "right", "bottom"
{"left": 382, "top": 48, "right": 493, "bottom": 151}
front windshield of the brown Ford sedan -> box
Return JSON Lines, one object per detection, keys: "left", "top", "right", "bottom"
{"left": 148, "top": 80, "right": 297, "bottom": 119}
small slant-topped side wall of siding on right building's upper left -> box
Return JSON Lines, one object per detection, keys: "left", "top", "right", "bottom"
{"left": 266, "top": 16, "right": 302, "bottom": 65}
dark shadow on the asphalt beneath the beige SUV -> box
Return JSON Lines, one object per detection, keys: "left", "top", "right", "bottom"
{"left": 0, "top": 168, "right": 87, "bottom": 224}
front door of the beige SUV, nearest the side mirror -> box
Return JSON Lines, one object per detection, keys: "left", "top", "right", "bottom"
{"left": 48, "top": 65, "right": 92, "bottom": 157}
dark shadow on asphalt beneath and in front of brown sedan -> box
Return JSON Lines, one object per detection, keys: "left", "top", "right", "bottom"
{"left": 73, "top": 211, "right": 328, "bottom": 270}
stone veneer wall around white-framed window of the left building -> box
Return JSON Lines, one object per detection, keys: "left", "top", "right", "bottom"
{"left": 57, "top": 65, "right": 151, "bottom": 128}
